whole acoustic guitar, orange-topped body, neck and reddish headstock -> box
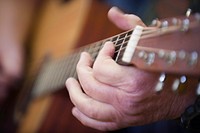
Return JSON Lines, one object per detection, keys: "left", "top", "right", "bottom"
{"left": 15, "top": 0, "right": 200, "bottom": 133}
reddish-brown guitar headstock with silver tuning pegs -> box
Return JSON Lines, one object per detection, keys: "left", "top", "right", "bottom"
{"left": 122, "top": 13, "right": 200, "bottom": 95}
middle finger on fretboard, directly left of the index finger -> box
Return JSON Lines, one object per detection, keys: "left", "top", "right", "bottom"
{"left": 77, "top": 53, "right": 115, "bottom": 103}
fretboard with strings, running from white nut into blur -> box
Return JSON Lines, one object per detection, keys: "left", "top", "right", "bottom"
{"left": 32, "top": 30, "right": 133, "bottom": 97}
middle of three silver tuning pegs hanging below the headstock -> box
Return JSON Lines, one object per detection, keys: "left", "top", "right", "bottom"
{"left": 172, "top": 76, "right": 187, "bottom": 93}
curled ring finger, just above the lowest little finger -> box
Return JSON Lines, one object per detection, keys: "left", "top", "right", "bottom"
{"left": 66, "top": 78, "right": 116, "bottom": 121}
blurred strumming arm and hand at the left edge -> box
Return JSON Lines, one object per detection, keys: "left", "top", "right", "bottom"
{"left": 0, "top": 0, "right": 36, "bottom": 105}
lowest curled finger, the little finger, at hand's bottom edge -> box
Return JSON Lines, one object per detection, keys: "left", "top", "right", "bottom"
{"left": 72, "top": 108, "right": 118, "bottom": 131}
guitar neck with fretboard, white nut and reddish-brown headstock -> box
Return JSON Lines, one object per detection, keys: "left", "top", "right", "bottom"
{"left": 16, "top": 0, "right": 200, "bottom": 131}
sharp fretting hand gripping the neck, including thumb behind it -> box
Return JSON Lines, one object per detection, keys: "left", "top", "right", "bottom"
{"left": 66, "top": 7, "right": 196, "bottom": 131}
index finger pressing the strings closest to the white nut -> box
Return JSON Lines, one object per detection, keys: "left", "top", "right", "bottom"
{"left": 93, "top": 42, "right": 132, "bottom": 85}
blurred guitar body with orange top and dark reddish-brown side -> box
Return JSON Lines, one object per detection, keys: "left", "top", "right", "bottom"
{"left": 15, "top": 0, "right": 121, "bottom": 133}
